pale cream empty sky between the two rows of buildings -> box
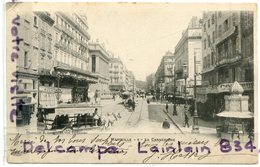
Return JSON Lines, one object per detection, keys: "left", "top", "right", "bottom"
{"left": 84, "top": 3, "right": 202, "bottom": 81}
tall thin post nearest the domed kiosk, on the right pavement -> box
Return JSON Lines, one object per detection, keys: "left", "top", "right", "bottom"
{"left": 192, "top": 56, "right": 199, "bottom": 133}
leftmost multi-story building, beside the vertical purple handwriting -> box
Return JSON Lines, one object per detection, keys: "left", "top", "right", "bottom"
{"left": 16, "top": 12, "right": 56, "bottom": 125}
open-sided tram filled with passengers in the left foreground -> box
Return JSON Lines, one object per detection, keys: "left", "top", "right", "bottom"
{"left": 37, "top": 104, "right": 102, "bottom": 134}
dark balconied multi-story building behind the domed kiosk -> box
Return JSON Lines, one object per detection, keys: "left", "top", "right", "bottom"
{"left": 198, "top": 11, "right": 254, "bottom": 118}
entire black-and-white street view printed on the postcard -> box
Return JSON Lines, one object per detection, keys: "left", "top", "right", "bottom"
{"left": 12, "top": 7, "right": 255, "bottom": 141}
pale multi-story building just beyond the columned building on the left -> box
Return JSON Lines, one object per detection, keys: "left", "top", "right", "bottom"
{"left": 109, "top": 58, "right": 127, "bottom": 92}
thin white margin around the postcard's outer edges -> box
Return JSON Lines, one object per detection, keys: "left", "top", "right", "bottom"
{"left": 0, "top": 0, "right": 260, "bottom": 167}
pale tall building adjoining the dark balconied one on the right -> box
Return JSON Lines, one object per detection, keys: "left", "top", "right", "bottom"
{"left": 174, "top": 17, "right": 202, "bottom": 97}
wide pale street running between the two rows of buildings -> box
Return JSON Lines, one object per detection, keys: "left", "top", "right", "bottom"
{"left": 88, "top": 98, "right": 216, "bottom": 133}
